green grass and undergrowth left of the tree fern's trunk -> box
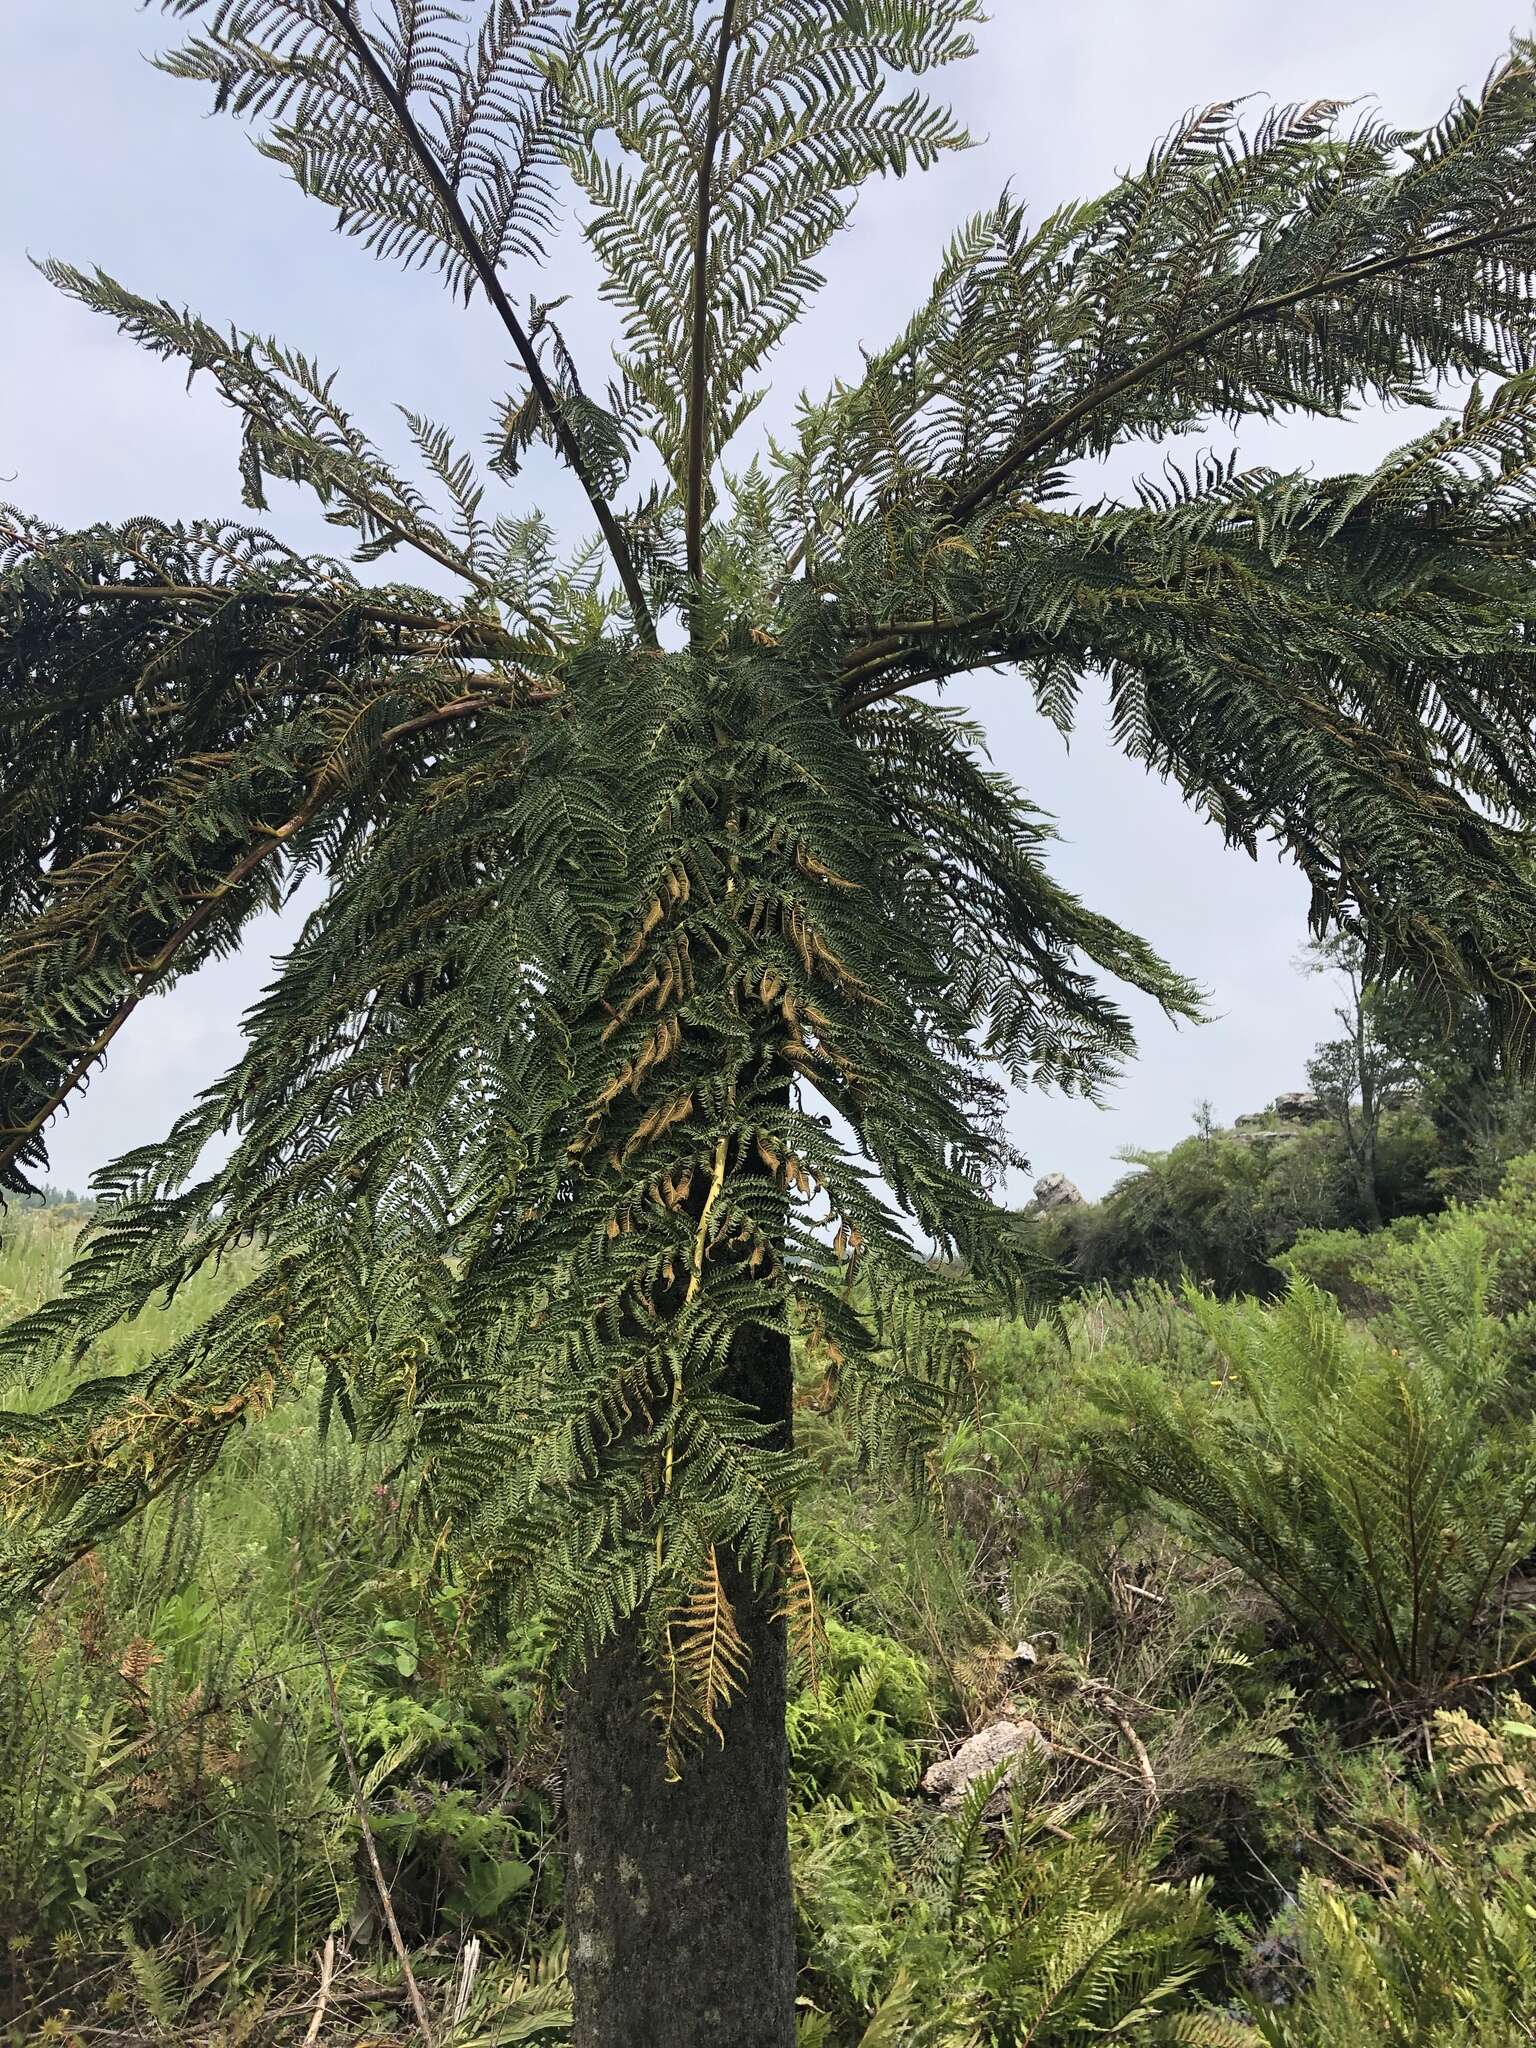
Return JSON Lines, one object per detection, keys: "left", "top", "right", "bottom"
{"left": 0, "top": 1214, "right": 569, "bottom": 2040}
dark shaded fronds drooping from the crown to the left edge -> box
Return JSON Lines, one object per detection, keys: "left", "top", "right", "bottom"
{"left": 0, "top": 512, "right": 561, "bottom": 1188}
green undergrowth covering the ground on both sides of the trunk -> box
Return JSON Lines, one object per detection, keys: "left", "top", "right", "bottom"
{"left": 0, "top": 1157, "right": 1536, "bottom": 2048}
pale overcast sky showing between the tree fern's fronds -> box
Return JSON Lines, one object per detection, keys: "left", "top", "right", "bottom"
{"left": 0, "top": 0, "right": 1528, "bottom": 1198}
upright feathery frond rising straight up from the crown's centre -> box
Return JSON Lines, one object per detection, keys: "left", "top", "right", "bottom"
{"left": 557, "top": 0, "right": 979, "bottom": 505}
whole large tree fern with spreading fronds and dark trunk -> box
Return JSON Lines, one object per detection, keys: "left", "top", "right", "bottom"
{"left": 15, "top": 12, "right": 1536, "bottom": 2048}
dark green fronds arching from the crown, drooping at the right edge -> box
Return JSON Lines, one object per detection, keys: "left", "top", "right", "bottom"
{"left": 794, "top": 391, "right": 1536, "bottom": 1055}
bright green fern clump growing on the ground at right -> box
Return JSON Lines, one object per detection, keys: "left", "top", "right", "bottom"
{"left": 1096, "top": 1227, "right": 1536, "bottom": 1708}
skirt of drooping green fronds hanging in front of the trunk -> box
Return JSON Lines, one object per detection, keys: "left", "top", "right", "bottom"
{"left": 0, "top": 639, "right": 1130, "bottom": 1679}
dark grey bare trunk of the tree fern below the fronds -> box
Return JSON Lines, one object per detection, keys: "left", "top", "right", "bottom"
{"left": 565, "top": 1333, "right": 795, "bottom": 2048}
